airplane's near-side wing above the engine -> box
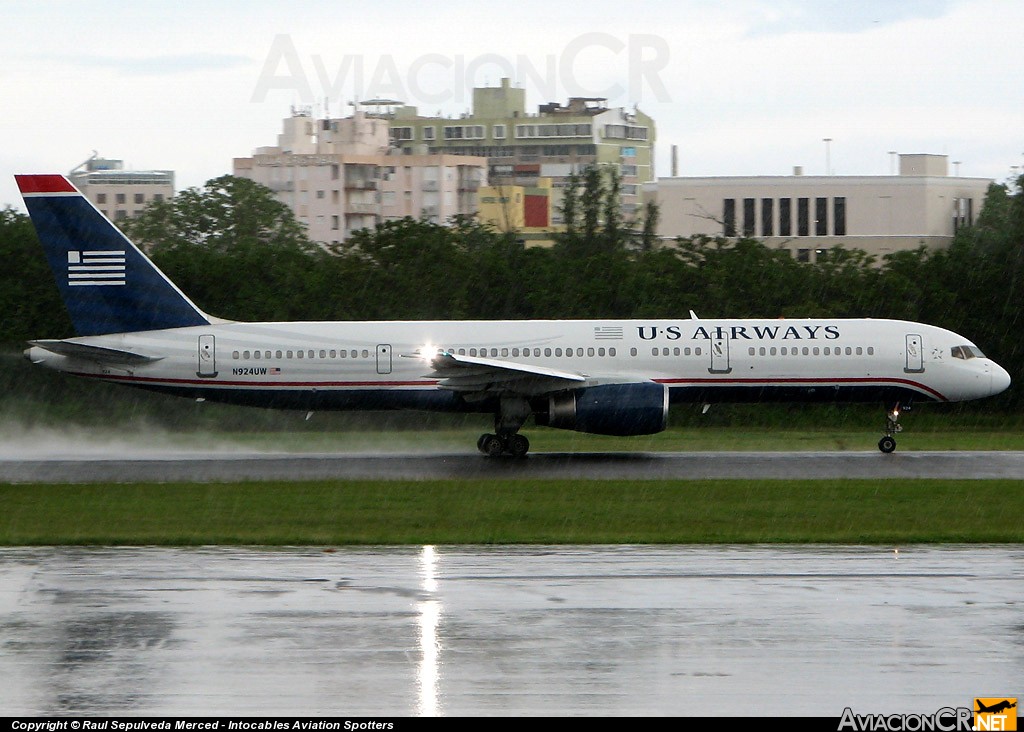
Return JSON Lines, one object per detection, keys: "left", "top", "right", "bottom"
{"left": 421, "top": 351, "right": 589, "bottom": 396}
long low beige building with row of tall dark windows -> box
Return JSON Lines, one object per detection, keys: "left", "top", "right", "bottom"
{"left": 645, "top": 155, "right": 992, "bottom": 262}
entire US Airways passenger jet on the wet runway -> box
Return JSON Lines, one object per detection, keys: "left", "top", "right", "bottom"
{"left": 15, "top": 175, "right": 1010, "bottom": 457}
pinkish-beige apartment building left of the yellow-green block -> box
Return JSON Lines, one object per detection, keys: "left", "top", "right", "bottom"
{"left": 233, "top": 110, "right": 487, "bottom": 245}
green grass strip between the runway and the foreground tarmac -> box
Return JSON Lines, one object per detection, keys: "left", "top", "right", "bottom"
{"left": 0, "top": 480, "right": 1024, "bottom": 546}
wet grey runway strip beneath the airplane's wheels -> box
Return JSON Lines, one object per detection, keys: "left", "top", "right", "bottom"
{"left": 0, "top": 450, "right": 1024, "bottom": 483}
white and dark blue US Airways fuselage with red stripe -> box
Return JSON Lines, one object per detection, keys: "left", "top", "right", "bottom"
{"left": 29, "top": 318, "right": 1010, "bottom": 411}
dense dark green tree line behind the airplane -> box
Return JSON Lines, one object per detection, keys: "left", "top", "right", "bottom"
{"left": 0, "top": 173, "right": 1024, "bottom": 408}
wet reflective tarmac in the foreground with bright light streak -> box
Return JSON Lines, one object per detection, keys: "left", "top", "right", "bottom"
{"left": 0, "top": 546, "right": 1024, "bottom": 718}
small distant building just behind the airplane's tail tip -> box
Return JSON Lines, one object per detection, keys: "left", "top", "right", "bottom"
{"left": 68, "top": 155, "right": 174, "bottom": 221}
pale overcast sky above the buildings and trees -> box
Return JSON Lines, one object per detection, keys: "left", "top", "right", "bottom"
{"left": 0, "top": 0, "right": 1024, "bottom": 208}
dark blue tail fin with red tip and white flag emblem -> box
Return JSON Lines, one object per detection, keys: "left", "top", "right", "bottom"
{"left": 14, "top": 175, "right": 210, "bottom": 336}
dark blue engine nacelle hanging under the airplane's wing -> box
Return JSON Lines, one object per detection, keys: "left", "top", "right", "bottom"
{"left": 538, "top": 382, "right": 669, "bottom": 436}
